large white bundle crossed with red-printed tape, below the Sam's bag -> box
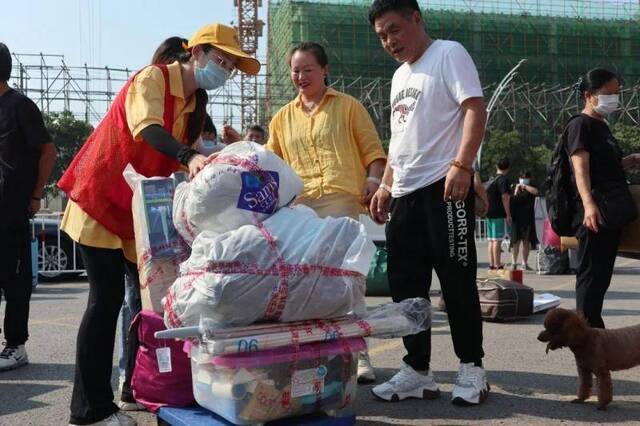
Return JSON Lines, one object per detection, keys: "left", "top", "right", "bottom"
{"left": 163, "top": 205, "right": 375, "bottom": 328}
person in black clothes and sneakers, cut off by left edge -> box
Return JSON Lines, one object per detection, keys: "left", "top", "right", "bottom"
{"left": 0, "top": 43, "right": 57, "bottom": 371}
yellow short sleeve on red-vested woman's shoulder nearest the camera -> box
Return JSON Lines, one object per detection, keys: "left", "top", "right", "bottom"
{"left": 125, "top": 66, "right": 165, "bottom": 140}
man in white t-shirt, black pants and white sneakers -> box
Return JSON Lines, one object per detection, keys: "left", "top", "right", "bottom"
{"left": 369, "top": 0, "right": 489, "bottom": 405}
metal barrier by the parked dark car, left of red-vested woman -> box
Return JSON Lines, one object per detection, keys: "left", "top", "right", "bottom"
{"left": 31, "top": 212, "right": 85, "bottom": 278}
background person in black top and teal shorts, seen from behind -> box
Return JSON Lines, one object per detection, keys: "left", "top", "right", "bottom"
{"left": 487, "top": 158, "right": 511, "bottom": 269}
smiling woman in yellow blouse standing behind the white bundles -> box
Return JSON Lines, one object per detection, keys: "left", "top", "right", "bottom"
{"left": 223, "top": 42, "right": 386, "bottom": 383}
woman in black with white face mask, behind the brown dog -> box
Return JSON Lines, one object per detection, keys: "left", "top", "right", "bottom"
{"left": 566, "top": 69, "right": 640, "bottom": 328}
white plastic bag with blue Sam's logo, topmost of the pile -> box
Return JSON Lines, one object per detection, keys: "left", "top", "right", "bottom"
{"left": 173, "top": 142, "right": 303, "bottom": 243}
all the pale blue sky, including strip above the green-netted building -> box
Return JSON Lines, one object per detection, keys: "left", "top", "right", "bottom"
{"left": 0, "top": 0, "right": 639, "bottom": 126}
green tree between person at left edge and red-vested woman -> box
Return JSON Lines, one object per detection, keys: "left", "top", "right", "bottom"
{"left": 44, "top": 111, "right": 93, "bottom": 195}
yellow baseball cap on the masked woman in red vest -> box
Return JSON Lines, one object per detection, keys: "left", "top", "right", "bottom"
{"left": 187, "top": 24, "right": 260, "bottom": 75}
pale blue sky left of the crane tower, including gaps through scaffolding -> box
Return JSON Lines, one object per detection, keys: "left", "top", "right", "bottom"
{"left": 0, "top": 0, "right": 267, "bottom": 126}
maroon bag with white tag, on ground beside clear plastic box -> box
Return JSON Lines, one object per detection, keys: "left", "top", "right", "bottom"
{"left": 131, "top": 310, "right": 195, "bottom": 413}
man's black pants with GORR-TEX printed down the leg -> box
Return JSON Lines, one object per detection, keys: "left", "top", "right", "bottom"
{"left": 386, "top": 179, "right": 484, "bottom": 370}
